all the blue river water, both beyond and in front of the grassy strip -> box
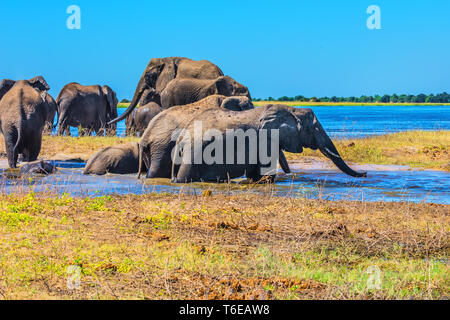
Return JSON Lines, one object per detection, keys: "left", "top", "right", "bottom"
{"left": 5, "top": 106, "right": 450, "bottom": 204}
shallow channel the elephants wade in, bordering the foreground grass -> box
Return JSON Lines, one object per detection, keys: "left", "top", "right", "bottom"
{"left": 0, "top": 162, "right": 450, "bottom": 204}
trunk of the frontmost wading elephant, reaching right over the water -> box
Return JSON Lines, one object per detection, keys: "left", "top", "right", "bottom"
{"left": 315, "top": 122, "right": 367, "bottom": 177}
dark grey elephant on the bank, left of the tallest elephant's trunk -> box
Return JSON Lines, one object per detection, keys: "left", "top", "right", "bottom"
{"left": 56, "top": 82, "right": 118, "bottom": 135}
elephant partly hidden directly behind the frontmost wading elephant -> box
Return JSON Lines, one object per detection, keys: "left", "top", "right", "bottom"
{"left": 138, "top": 95, "right": 253, "bottom": 178}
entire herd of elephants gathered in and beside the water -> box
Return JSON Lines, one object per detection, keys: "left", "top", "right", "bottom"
{"left": 0, "top": 57, "right": 366, "bottom": 183}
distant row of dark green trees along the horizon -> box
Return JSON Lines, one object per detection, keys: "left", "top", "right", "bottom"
{"left": 253, "top": 92, "right": 450, "bottom": 103}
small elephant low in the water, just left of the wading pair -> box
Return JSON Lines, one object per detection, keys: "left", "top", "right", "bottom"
{"left": 83, "top": 142, "right": 146, "bottom": 175}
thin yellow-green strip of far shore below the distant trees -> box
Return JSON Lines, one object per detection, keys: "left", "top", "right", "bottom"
{"left": 117, "top": 101, "right": 450, "bottom": 108}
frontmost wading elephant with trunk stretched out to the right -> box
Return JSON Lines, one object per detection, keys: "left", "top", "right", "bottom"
{"left": 171, "top": 105, "right": 366, "bottom": 183}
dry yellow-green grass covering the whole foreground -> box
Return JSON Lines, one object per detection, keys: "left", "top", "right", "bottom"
{"left": 0, "top": 192, "right": 450, "bottom": 299}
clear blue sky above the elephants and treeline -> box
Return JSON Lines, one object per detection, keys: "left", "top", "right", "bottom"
{"left": 0, "top": 0, "right": 450, "bottom": 99}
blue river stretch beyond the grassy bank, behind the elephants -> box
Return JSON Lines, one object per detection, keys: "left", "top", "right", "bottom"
{"left": 56, "top": 105, "right": 450, "bottom": 138}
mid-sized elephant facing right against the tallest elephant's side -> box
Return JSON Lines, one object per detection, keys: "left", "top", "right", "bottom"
{"left": 161, "top": 76, "right": 250, "bottom": 109}
